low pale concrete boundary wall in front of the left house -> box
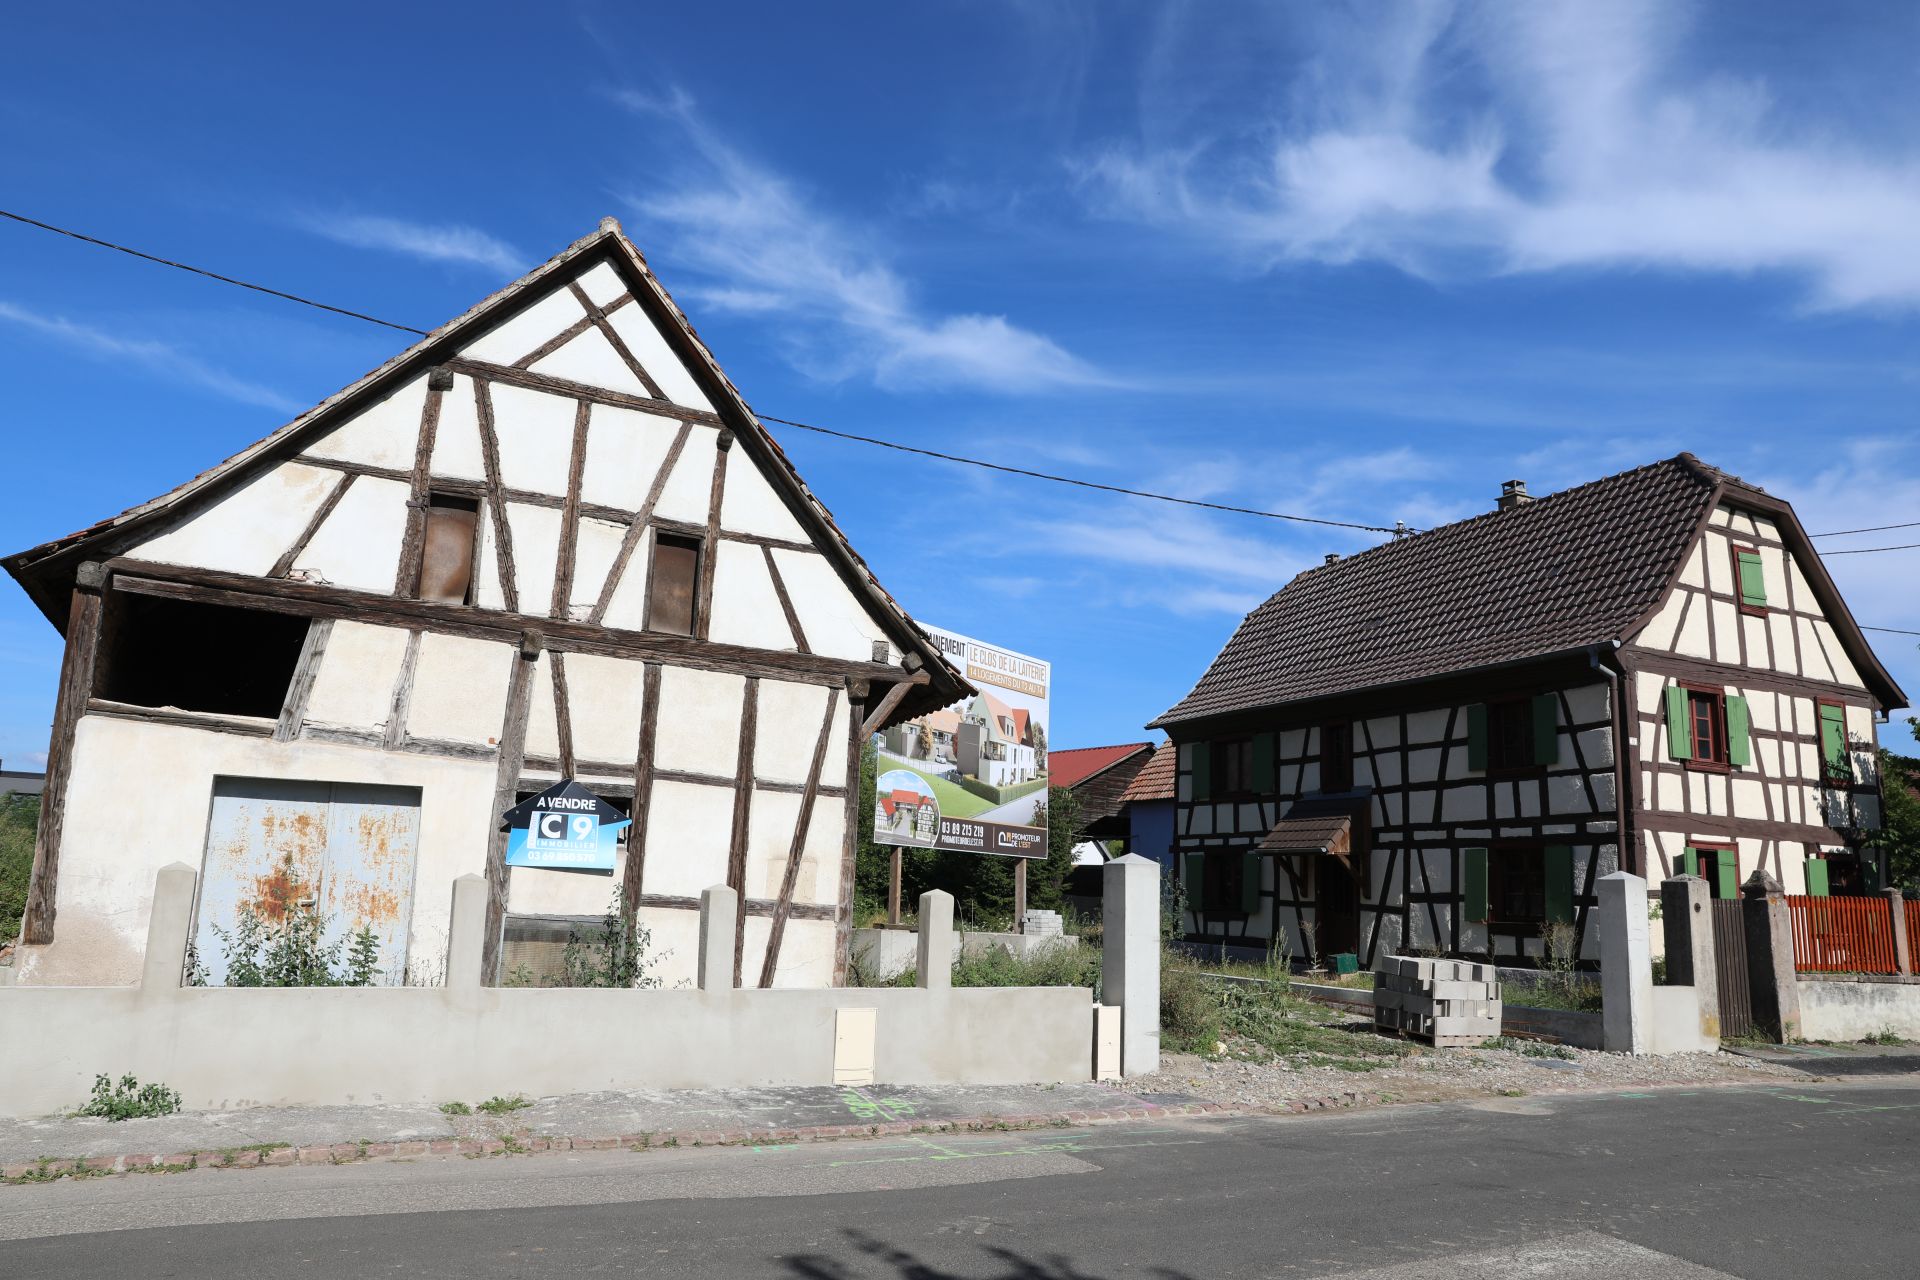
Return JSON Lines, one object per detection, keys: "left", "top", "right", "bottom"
{"left": 0, "top": 864, "right": 1094, "bottom": 1115}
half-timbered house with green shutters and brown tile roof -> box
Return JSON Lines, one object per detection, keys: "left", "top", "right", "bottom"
{"left": 1154, "top": 453, "right": 1905, "bottom": 963}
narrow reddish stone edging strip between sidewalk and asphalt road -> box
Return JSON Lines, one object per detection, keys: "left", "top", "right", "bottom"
{"left": 11, "top": 1094, "right": 1377, "bottom": 1186}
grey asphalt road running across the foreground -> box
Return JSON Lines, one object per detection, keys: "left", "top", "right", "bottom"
{"left": 0, "top": 1084, "right": 1920, "bottom": 1280}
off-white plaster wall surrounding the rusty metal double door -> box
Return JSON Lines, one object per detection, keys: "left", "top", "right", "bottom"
{"left": 15, "top": 716, "right": 493, "bottom": 990}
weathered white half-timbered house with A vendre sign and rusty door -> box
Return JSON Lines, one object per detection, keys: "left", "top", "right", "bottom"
{"left": 6, "top": 221, "right": 973, "bottom": 986}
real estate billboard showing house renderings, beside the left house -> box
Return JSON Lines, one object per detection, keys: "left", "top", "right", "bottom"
{"left": 874, "top": 628, "right": 1052, "bottom": 858}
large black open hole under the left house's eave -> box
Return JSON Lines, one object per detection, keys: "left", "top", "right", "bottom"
{"left": 94, "top": 591, "right": 307, "bottom": 718}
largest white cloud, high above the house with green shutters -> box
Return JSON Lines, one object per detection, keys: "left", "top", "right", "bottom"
{"left": 1085, "top": 0, "right": 1920, "bottom": 309}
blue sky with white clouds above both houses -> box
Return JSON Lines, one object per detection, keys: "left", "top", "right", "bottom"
{"left": 0, "top": 4, "right": 1920, "bottom": 764}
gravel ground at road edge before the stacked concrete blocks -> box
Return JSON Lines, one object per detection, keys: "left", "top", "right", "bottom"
{"left": 1127, "top": 1032, "right": 1807, "bottom": 1109}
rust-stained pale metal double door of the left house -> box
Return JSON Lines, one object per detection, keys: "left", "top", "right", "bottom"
{"left": 194, "top": 777, "right": 420, "bottom": 986}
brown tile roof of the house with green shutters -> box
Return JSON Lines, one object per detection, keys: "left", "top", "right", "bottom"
{"left": 1154, "top": 453, "right": 1728, "bottom": 725}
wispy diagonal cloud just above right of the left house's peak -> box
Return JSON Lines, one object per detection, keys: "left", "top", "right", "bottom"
{"left": 614, "top": 90, "right": 1114, "bottom": 391}
